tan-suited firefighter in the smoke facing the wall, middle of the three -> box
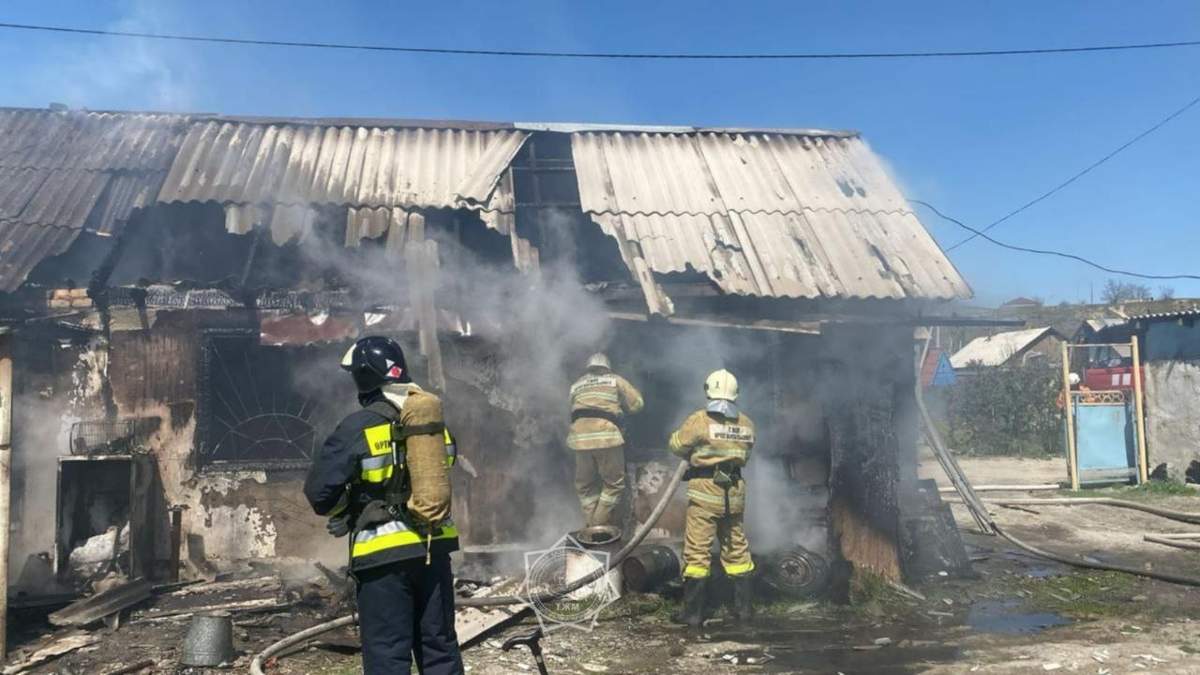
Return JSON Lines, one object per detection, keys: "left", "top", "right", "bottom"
{"left": 566, "top": 353, "right": 643, "bottom": 526}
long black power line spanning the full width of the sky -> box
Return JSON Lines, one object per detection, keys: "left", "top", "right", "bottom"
{"left": 0, "top": 23, "right": 1200, "bottom": 61}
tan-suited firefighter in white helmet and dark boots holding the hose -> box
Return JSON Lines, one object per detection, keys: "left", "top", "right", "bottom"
{"left": 670, "top": 370, "right": 755, "bottom": 631}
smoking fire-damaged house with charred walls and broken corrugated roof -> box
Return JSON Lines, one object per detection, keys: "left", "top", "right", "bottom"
{"left": 0, "top": 109, "right": 970, "bottom": 605}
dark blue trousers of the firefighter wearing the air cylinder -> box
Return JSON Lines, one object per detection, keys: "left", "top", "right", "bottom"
{"left": 354, "top": 554, "right": 463, "bottom": 675}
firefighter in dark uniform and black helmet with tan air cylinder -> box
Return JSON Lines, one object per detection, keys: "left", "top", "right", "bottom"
{"left": 304, "top": 336, "right": 463, "bottom": 675}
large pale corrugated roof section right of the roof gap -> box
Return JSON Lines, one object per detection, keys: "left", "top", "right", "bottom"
{"left": 571, "top": 132, "right": 971, "bottom": 303}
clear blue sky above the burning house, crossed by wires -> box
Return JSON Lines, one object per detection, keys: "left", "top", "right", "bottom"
{"left": 0, "top": 0, "right": 1200, "bottom": 304}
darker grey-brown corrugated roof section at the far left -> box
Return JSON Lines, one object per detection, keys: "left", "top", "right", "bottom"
{"left": 0, "top": 108, "right": 187, "bottom": 291}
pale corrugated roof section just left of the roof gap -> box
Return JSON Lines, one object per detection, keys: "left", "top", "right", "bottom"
{"left": 160, "top": 120, "right": 527, "bottom": 209}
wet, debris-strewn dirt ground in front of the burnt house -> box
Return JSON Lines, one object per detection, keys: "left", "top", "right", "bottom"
{"left": 9, "top": 458, "right": 1200, "bottom": 675}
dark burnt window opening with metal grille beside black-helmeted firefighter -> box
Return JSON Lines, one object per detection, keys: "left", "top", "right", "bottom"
{"left": 196, "top": 333, "right": 337, "bottom": 470}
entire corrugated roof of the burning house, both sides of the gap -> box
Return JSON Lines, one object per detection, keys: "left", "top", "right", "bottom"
{"left": 0, "top": 109, "right": 971, "bottom": 313}
